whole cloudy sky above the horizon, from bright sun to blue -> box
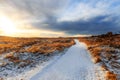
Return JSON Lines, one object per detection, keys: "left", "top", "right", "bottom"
{"left": 0, "top": 0, "right": 120, "bottom": 37}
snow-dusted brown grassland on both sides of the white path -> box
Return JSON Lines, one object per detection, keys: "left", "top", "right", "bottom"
{"left": 0, "top": 32, "right": 120, "bottom": 80}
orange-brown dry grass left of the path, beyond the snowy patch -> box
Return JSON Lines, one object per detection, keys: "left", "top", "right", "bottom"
{"left": 0, "top": 37, "right": 74, "bottom": 63}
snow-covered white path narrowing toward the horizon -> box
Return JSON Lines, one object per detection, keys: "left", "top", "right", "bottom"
{"left": 31, "top": 40, "right": 104, "bottom": 80}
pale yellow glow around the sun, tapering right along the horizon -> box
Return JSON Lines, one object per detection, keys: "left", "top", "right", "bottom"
{"left": 0, "top": 15, "right": 65, "bottom": 37}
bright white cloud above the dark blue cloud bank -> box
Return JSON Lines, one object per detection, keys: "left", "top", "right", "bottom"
{"left": 58, "top": 0, "right": 120, "bottom": 21}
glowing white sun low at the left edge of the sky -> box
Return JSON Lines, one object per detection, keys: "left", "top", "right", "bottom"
{"left": 0, "top": 16, "right": 17, "bottom": 35}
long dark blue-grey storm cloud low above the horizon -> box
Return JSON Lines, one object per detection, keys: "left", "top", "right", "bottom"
{"left": 34, "top": 16, "right": 120, "bottom": 34}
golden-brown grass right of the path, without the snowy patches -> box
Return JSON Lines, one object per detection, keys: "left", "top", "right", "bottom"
{"left": 79, "top": 32, "right": 120, "bottom": 80}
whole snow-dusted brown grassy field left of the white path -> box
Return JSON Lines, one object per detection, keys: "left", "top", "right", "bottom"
{"left": 0, "top": 36, "right": 75, "bottom": 80}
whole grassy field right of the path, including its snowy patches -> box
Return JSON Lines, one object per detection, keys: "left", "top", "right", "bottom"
{"left": 79, "top": 32, "right": 120, "bottom": 80}
